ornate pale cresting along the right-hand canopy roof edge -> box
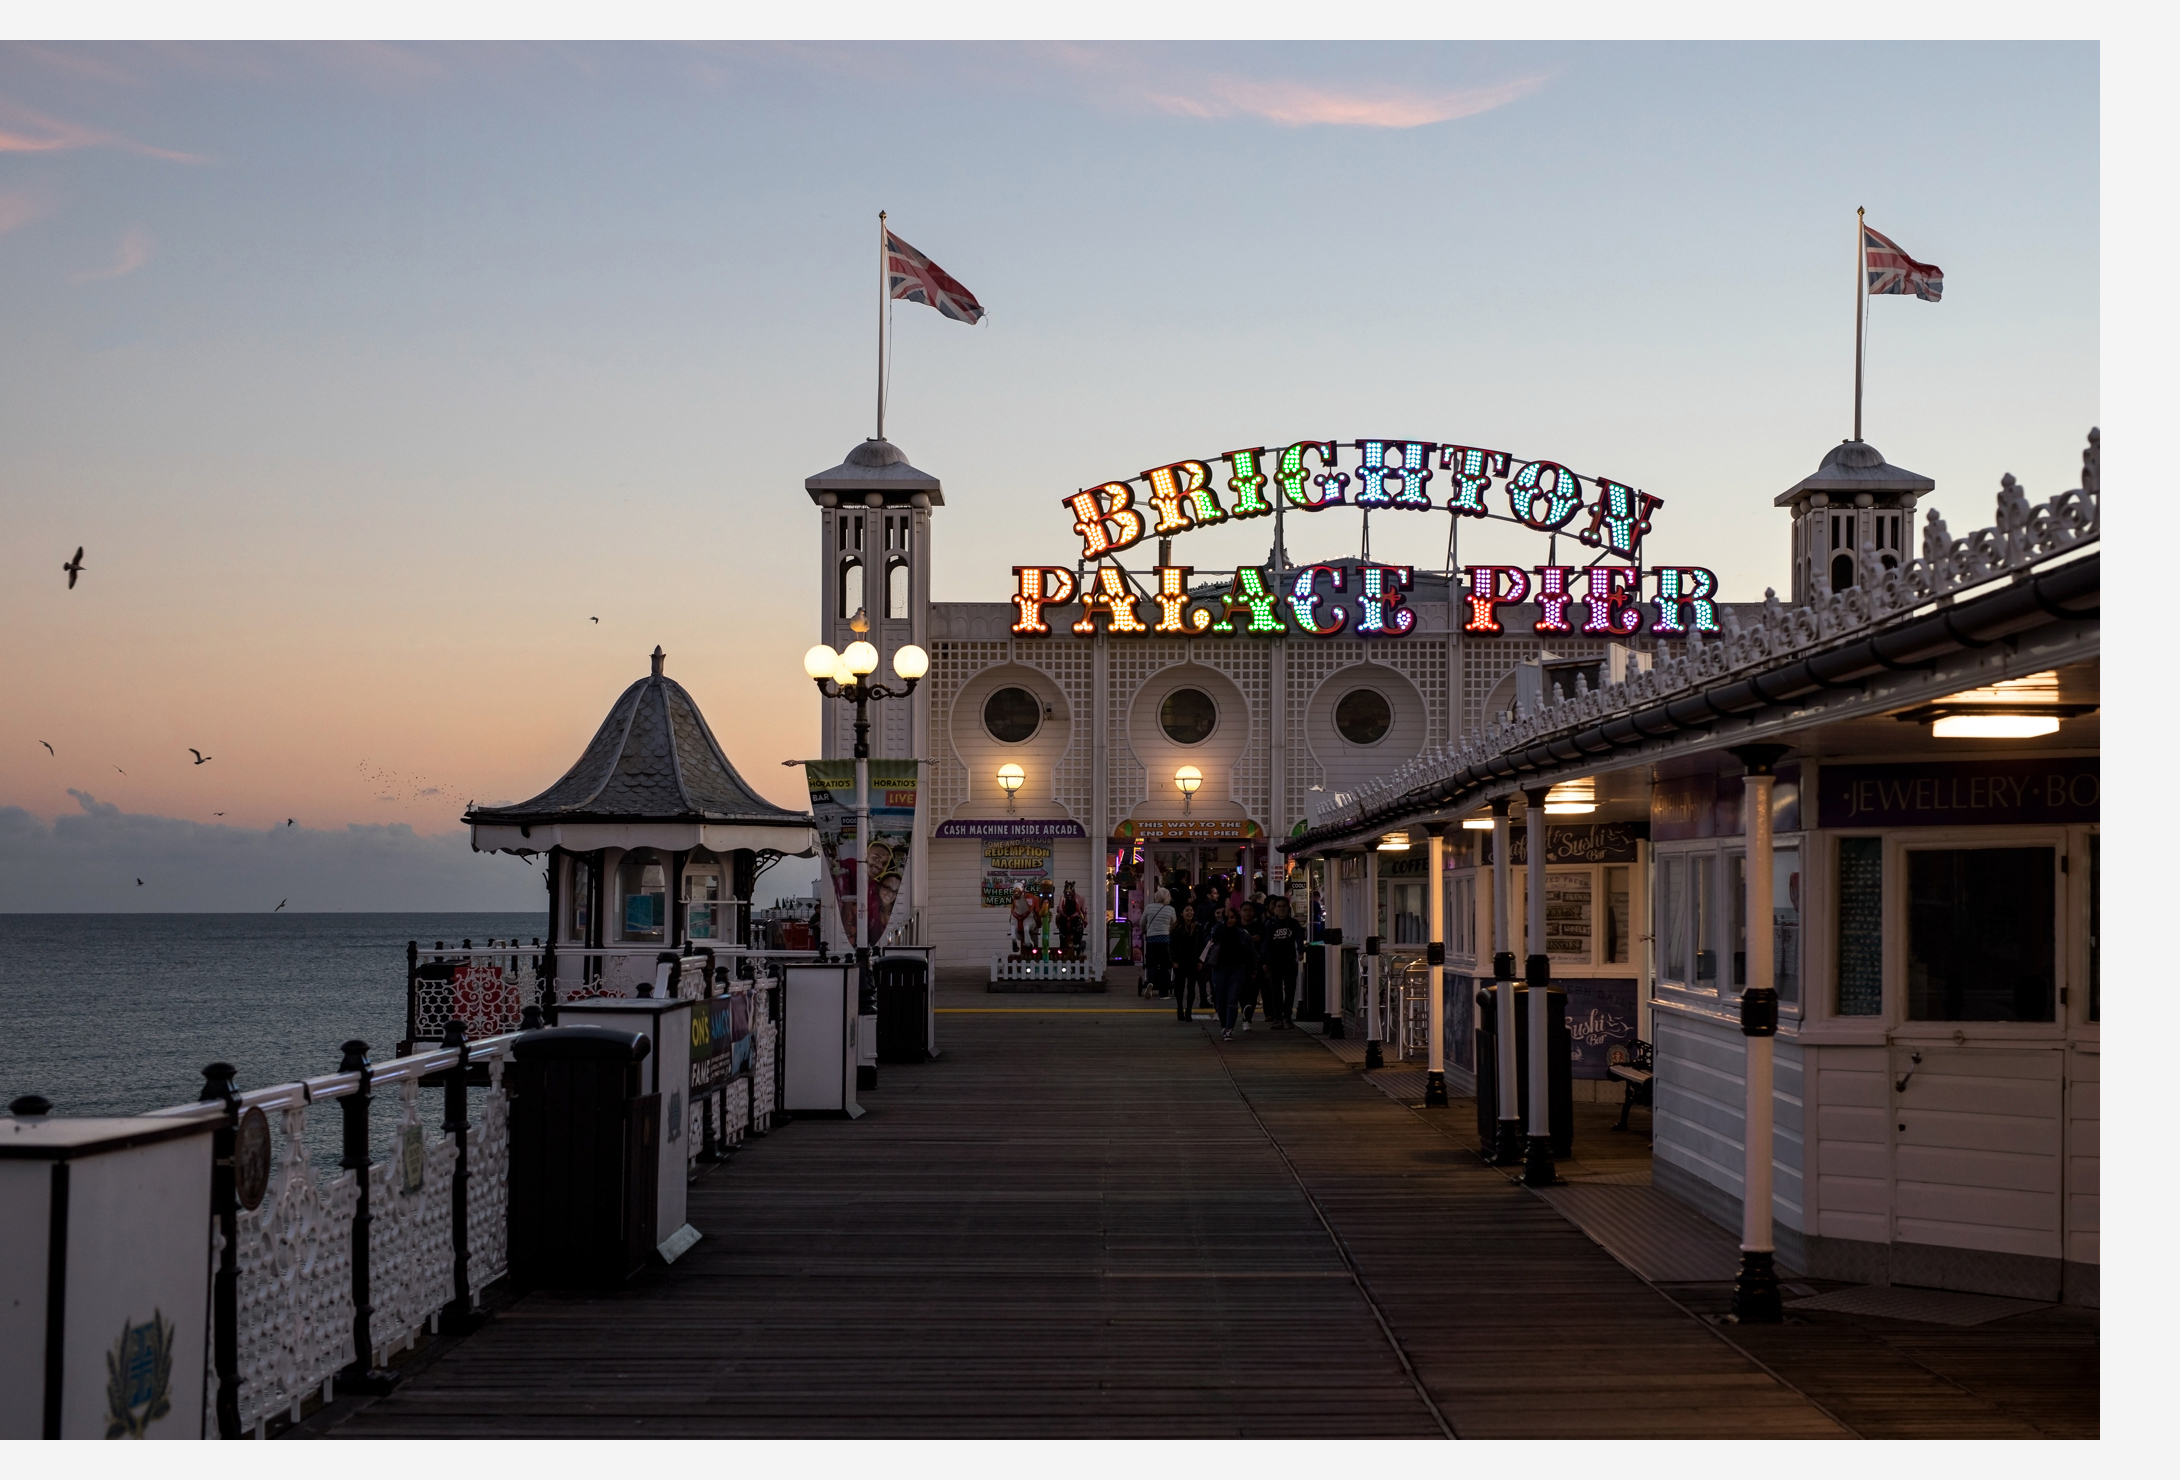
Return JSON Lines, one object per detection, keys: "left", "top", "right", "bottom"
{"left": 1310, "top": 429, "right": 2102, "bottom": 828}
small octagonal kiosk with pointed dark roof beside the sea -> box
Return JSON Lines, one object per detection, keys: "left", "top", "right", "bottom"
{"left": 462, "top": 650, "right": 818, "bottom": 1003}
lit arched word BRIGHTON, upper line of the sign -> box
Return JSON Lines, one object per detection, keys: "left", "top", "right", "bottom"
{"left": 1059, "top": 438, "right": 1663, "bottom": 560}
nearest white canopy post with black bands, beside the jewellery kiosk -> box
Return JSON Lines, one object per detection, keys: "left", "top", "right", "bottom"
{"left": 1733, "top": 745, "right": 1788, "bottom": 1325}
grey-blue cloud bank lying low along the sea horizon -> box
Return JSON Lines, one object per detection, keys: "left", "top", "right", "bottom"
{"left": 0, "top": 789, "right": 541, "bottom": 913}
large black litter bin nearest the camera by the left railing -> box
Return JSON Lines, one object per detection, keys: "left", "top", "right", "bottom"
{"left": 508, "top": 1027, "right": 658, "bottom": 1288}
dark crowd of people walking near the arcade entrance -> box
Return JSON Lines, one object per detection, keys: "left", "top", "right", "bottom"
{"left": 1138, "top": 876, "right": 1306, "bottom": 1038}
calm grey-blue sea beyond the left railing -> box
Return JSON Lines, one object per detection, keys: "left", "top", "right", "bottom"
{"left": 0, "top": 911, "right": 545, "bottom": 1166}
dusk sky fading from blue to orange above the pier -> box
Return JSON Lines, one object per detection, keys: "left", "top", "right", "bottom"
{"left": 0, "top": 44, "right": 2099, "bottom": 911}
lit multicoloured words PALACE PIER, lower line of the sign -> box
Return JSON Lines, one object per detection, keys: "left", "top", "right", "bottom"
{"left": 1012, "top": 562, "right": 1718, "bottom": 636}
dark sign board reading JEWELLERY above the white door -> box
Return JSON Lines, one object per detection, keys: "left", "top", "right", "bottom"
{"left": 1816, "top": 756, "right": 2099, "bottom": 828}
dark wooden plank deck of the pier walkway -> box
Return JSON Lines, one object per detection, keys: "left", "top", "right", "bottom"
{"left": 322, "top": 992, "right": 2095, "bottom": 1439}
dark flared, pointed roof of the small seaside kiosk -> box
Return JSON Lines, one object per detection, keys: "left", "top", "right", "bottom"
{"left": 462, "top": 650, "right": 811, "bottom": 828}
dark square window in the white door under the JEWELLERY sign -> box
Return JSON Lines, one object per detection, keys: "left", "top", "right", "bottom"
{"left": 1908, "top": 848, "right": 2058, "bottom": 1022}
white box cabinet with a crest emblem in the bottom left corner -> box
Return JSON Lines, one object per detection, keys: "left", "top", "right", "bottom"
{"left": 0, "top": 1094, "right": 218, "bottom": 1439}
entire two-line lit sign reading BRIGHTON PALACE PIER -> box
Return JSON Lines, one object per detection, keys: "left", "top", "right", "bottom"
{"left": 1012, "top": 440, "right": 1718, "bottom": 636}
